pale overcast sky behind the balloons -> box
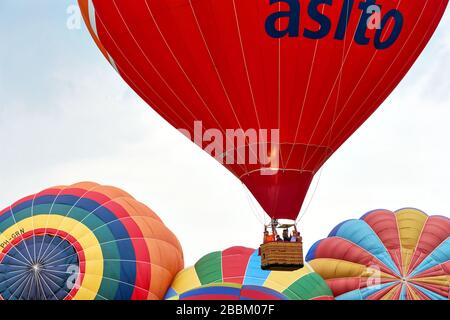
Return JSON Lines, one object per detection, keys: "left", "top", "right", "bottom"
{"left": 0, "top": 0, "right": 450, "bottom": 265}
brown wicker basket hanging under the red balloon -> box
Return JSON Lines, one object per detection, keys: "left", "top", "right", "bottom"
{"left": 260, "top": 241, "right": 304, "bottom": 271}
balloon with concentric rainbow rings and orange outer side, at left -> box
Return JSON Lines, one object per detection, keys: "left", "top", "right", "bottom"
{"left": 0, "top": 182, "right": 183, "bottom": 300}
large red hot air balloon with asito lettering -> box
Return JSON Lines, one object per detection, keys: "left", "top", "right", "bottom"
{"left": 79, "top": 0, "right": 448, "bottom": 220}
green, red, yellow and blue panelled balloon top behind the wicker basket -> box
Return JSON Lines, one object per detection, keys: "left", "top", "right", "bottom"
{"left": 166, "top": 247, "right": 332, "bottom": 300}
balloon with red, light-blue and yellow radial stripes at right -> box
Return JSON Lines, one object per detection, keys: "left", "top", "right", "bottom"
{"left": 306, "top": 208, "right": 450, "bottom": 300}
